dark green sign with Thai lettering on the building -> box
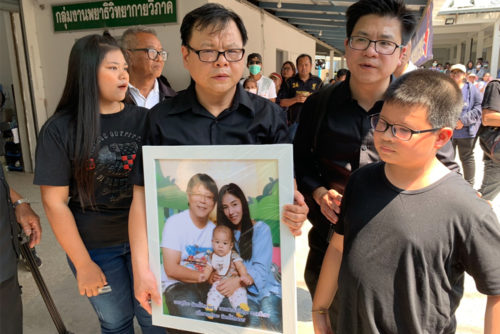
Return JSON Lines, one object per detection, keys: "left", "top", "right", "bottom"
{"left": 52, "top": 0, "right": 177, "bottom": 31}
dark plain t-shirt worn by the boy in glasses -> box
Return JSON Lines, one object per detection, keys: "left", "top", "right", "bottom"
{"left": 336, "top": 163, "right": 500, "bottom": 334}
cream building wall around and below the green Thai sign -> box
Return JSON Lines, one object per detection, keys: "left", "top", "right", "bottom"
{"left": 22, "top": 0, "right": 315, "bottom": 127}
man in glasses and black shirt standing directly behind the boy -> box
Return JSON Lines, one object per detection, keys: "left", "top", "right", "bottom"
{"left": 294, "top": 0, "right": 458, "bottom": 296}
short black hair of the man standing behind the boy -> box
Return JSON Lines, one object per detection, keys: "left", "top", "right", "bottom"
{"left": 346, "top": 0, "right": 417, "bottom": 45}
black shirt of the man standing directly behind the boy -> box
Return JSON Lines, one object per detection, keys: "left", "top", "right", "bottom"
{"left": 293, "top": 75, "right": 458, "bottom": 244}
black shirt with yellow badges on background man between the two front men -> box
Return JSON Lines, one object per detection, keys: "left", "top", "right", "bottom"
{"left": 280, "top": 74, "right": 323, "bottom": 124}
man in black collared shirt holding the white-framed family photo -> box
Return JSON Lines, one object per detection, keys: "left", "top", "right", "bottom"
{"left": 129, "top": 4, "right": 308, "bottom": 332}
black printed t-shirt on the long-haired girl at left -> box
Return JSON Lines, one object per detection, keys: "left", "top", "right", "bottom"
{"left": 34, "top": 104, "right": 148, "bottom": 249}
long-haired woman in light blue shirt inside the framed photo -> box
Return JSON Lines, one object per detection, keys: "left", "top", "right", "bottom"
{"left": 217, "top": 183, "right": 283, "bottom": 332}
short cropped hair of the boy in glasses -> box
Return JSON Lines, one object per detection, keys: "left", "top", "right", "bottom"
{"left": 384, "top": 69, "right": 463, "bottom": 129}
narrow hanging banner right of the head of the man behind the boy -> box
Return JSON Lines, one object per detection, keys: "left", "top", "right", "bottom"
{"left": 411, "top": 1, "right": 434, "bottom": 66}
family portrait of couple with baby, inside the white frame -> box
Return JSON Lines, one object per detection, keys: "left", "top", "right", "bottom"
{"left": 142, "top": 148, "right": 293, "bottom": 333}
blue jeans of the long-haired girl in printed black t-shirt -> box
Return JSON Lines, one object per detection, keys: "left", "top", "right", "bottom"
{"left": 68, "top": 243, "right": 165, "bottom": 334}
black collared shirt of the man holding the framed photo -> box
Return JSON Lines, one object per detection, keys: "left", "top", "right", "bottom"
{"left": 131, "top": 85, "right": 289, "bottom": 185}
